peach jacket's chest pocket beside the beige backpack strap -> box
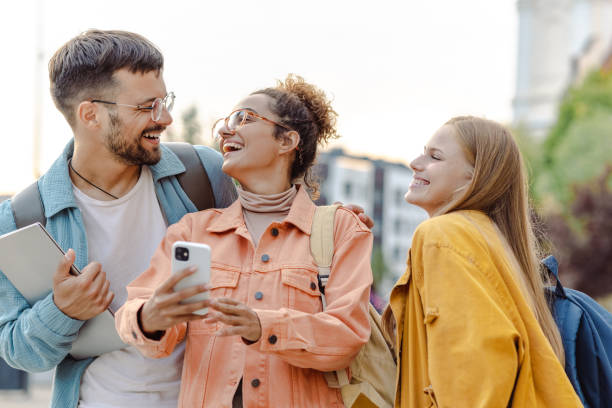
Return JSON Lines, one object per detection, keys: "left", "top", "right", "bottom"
{"left": 281, "top": 268, "right": 323, "bottom": 313}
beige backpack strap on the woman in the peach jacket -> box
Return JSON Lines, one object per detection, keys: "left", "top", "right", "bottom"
{"left": 310, "top": 204, "right": 349, "bottom": 388}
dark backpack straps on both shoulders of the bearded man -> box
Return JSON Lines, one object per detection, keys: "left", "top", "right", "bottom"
{"left": 11, "top": 142, "right": 215, "bottom": 228}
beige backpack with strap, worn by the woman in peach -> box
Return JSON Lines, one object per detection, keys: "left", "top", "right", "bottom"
{"left": 310, "top": 205, "right": 397, "bottom": 408}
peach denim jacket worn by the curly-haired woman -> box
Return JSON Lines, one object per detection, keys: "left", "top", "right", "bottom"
{"left": 115, "top": 189, "right": 372, "bottom": 408}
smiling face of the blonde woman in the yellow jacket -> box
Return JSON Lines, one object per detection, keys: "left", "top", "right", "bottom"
{"left": 404, "top": 125, "right": 473, "bottom": 216}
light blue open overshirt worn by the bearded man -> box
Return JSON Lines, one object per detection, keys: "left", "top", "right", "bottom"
{"left": 0, "top": 140, "right": 236, "bottom": 408}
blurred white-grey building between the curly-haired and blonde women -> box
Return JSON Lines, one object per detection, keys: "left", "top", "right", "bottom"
{"left": 314, "top": 149, "right": 427, "bottom": 295}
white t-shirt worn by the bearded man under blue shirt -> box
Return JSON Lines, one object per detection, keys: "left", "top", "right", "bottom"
{"left": 73, "top": 166, "right": 185, "bottom": 408}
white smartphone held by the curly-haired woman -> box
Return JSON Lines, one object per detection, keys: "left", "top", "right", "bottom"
{"left": 172, "top": 241, "right": 210, "bottom": 315}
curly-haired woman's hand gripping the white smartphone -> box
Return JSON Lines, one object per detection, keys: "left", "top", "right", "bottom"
{"left": 140, "top": 267, "right": 210, "bottom": 338}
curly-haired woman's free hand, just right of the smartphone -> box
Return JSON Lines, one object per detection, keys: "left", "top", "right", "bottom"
{"left": 205, "top": 298, "right": 261, "bottom": 343}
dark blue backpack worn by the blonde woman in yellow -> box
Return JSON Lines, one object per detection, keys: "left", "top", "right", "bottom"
{"left": 542, "top": 256, "right": 612, "bottom": 408}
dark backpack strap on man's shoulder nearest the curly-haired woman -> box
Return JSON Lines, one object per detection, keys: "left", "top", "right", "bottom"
{"left": 164, "top": 142, "right": 215, "bottom": 211}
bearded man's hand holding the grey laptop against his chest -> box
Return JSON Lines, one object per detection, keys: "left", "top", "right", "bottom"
{"left": 53, "top": 249, "right": 115, "bottom": 320}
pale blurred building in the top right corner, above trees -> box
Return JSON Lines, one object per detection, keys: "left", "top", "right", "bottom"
{"left": 513, "top": 0, "right": 612, "bottom": 137}
